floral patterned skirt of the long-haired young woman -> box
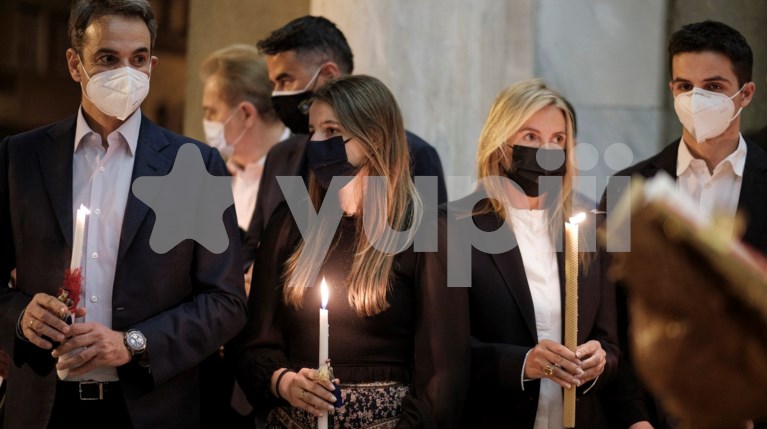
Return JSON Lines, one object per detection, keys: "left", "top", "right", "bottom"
{"left": 266, "top": 381, "right": 410, "bottom": 429}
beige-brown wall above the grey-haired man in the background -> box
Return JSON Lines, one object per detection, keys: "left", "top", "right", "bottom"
{"left": 184, "top": 0, "right": 309, "bottom": 140}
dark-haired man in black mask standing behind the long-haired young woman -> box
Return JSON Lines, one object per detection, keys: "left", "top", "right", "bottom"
{"left": 243, "top": 16, "right": 447, "bottom": 263}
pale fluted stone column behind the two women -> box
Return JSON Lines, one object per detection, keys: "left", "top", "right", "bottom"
{"left": 311, "top": 0, "right": 535, "bottom": 199}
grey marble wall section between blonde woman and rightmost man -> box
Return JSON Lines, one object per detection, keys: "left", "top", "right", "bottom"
{"left": 535, "top": 0, "right": 668, "bottom": 201}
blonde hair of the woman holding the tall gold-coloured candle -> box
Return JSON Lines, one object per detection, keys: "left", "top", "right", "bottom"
{"left": 474, "top": 79, "right": 590, "bottom": 265}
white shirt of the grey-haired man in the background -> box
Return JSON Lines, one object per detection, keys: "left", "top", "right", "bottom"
{"left": 227, "top": 127, "right": 290, "bottom": 231}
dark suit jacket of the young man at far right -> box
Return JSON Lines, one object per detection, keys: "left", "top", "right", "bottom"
{"left": 600, "top": 140, "right": 767, "bottom": 429}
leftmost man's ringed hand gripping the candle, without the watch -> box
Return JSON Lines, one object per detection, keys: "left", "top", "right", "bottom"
{"left": 19, "top": 293, "right": 85, "bottom": 349}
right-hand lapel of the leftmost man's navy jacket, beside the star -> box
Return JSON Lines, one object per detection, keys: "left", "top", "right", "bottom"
{"left": 117, "top": 116, "right": 175, "bottom": 261}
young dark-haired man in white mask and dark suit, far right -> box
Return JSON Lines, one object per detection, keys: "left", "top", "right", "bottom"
{"left": 602, "top": 21, "right": 767, "bottom": 429}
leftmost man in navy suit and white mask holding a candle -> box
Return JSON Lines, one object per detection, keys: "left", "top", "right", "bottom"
{"left": 0, "top": 0, "right": 246, "bottom": 429}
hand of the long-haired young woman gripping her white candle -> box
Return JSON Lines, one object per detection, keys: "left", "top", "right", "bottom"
{"left": 272, "top": 368, "right": 336, "bottom": 417}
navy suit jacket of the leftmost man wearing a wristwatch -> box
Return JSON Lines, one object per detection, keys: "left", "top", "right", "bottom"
{"left": 0, "top": 113, "right": 247, "bottom": 429}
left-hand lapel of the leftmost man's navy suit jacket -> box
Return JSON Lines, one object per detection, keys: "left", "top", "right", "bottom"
{"left": 38, "top": 117, "right": 76, "bottom": 248}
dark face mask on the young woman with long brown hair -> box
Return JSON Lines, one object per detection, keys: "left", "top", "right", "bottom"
{"left": 306, "top": 136, "right": 359, "bottom": 190}
